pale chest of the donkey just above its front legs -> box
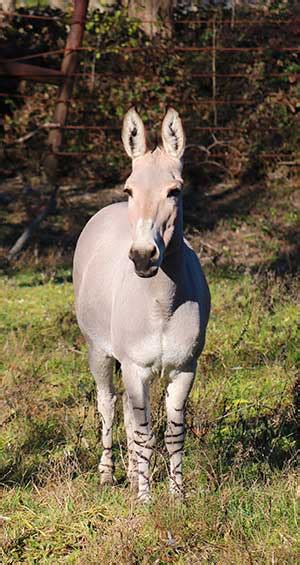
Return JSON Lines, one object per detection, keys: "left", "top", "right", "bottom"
{"left": 113, "top": 298, "right": 200, "bottom": 370}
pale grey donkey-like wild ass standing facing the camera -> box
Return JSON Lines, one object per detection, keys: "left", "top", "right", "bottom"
{"left": 73, "top": 108, "right": 210, "bottom": 501}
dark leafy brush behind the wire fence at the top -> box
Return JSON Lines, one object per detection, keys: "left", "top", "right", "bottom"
{"left": 2, "top": 2, "right": 300, "bottom": 184}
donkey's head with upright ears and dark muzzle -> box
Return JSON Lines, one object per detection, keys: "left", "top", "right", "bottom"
{"left": 122, "top": 108, "right": 185, "bottom": 277}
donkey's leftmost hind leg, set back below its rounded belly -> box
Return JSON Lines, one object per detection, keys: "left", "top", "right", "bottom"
{"left": 89, "top": 347, "right": 116, "bottom": 485}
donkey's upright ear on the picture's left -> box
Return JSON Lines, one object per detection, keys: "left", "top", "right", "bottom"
{"left": 122, "top": 108, "right": 147, "bottom": 159}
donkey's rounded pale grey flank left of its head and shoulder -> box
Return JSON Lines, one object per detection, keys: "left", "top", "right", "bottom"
{"left": 73, "top": 202, "right": 130, "bottom": 354}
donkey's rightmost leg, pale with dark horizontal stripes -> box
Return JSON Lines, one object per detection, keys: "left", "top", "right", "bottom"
{"left": 165, "top": 371, "right": 195, "bottom": 496}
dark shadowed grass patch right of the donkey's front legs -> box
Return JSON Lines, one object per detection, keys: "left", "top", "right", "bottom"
{"left": 188, "top": 379, "right": 300, "bottom": 484}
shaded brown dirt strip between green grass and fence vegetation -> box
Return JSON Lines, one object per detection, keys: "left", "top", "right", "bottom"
{"left": 0, "top": 166, "right": 300, "bottom": 274}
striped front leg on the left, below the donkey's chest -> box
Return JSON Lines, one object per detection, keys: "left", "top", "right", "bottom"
{"left": 122, "top": 363, "right": 154, "bottom": 502}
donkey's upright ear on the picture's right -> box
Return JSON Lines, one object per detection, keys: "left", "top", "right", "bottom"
{"left": 161, "top": 108, "right": 185, "bottom": 159}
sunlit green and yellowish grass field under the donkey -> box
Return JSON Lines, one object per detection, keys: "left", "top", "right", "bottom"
{"left": 0, "top": 269, "right": 300, "bottom": 565}
